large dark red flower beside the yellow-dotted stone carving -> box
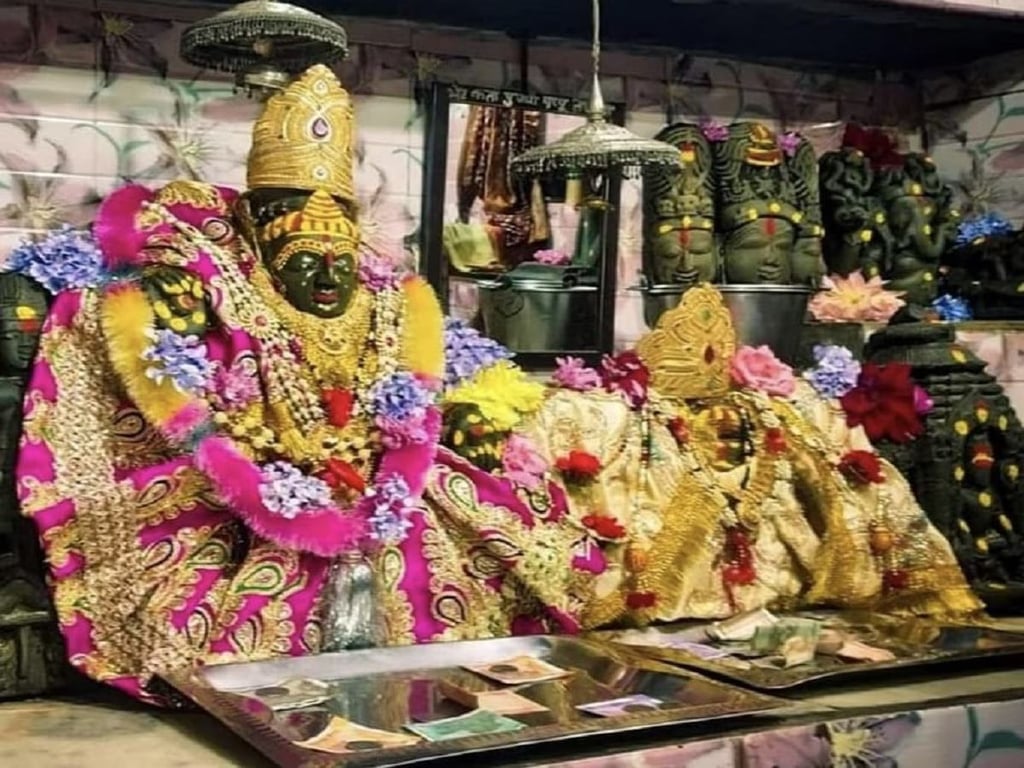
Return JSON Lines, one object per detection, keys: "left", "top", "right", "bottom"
{"left": 840, "top": 362, "right": 925, "bottom": 442}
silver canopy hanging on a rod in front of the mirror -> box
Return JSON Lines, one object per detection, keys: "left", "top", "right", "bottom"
{"left": 512, "top": 0, "right": 679, "bottom": 175}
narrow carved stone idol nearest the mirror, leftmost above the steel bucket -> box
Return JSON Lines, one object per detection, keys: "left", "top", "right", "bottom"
{"left": 643, "top": 123, "right": 720, "bottom": 286}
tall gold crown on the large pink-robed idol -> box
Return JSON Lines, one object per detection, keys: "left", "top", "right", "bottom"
{"left": 248, "top": 65, "right": 355, "bottom": 210}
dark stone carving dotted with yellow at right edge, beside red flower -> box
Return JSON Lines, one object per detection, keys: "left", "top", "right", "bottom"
{"left": 867, "top": 323, "right": 1024, "bottom": 607}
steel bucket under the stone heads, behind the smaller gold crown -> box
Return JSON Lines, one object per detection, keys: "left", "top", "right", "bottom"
{"left": 636, "top": 284, "right": 813, "bottom": 366}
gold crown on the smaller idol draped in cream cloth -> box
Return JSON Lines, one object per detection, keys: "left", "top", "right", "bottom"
{"left": 637, "top": 284, "right": 736, "bottom": 400}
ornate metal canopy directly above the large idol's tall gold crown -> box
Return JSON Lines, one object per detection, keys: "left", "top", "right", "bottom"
{"left": 181, "top": 0, "right": 348, "bottom": 94}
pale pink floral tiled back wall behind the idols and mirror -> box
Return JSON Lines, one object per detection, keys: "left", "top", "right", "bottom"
{"left": 0, "top": 0, "right": 933, "bottom": 344}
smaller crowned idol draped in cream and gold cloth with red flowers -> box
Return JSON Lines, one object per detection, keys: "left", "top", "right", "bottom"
{"left": 524, "top": 285, "right": 980, "bottom": 627}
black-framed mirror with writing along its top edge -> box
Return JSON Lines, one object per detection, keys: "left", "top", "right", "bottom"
{"left": 420, "top": 83, "right": 625, "bottom": 370}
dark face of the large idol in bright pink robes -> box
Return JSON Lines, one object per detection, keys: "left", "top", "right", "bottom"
{"left": 263, "top": 234, "right": 356, "bottom": 318}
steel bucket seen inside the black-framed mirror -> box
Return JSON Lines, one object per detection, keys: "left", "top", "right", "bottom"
{"left": 479, "top": 281, "right": 598, "bottom": 352}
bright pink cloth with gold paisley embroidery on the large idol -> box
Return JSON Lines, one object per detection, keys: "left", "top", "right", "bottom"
{"left": 17, "top": 185, "right": 599, "bottom": 702}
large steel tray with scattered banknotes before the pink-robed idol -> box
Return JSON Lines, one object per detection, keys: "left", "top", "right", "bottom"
{"left": 165, "top": 636, "right": 788, "bottom": 768}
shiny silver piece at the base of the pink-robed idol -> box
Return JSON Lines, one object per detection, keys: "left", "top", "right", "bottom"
{"left": 321, "top": 554, "right": 379, "bottom": 653}
